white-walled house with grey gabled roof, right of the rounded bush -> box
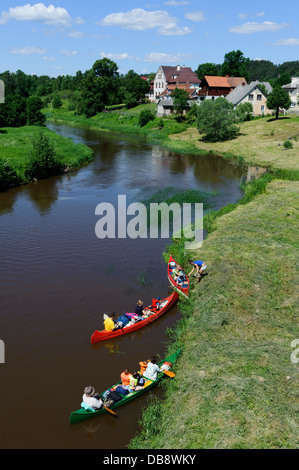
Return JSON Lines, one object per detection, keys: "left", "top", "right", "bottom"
{"left": 226, "top": 82, "right": 272, "bottom": 116}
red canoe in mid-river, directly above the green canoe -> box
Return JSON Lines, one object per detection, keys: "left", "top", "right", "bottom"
{"left": 90, "top": 292, "right": 179, "bottom": 343}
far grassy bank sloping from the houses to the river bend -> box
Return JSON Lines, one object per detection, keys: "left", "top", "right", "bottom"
{"left": 44, "top": 102, "right": 299, "bottom": 170}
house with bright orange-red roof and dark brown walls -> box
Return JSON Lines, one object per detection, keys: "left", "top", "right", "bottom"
{"left": 198, "top": 75, "right": 247, "bottom": 101}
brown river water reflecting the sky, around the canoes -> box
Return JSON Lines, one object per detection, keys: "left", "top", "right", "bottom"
{"left": 0, "top": 124, "right": 243, "bottom": 449}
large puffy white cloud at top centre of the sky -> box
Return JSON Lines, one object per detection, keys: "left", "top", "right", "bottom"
{"left": 99, "top": 8, "right": 191, "bottom": 36}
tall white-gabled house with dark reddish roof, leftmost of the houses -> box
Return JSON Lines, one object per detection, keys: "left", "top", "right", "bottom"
{"left": 149, "top": 65, "right": 200, "bottom": 100}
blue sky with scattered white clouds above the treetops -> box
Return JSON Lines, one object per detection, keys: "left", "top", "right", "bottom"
{"left": 0, "top": 0, "right": 299, "bottom": 77}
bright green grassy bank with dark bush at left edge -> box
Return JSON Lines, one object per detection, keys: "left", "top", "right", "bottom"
{"left": 0, "top": 126, "right": 93, "bottom": 187}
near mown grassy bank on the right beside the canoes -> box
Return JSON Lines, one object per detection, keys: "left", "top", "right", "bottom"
{"left": 130, "top": 176, "right": 299, "bottom": 449}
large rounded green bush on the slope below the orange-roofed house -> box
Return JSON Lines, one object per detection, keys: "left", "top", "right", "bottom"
{"left": 196, "top": 97, "right": 239, "bottom": 142}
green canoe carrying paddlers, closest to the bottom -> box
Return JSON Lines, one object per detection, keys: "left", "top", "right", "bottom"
{"left": 70, "top": 350, "right": 181, "bottom": 424}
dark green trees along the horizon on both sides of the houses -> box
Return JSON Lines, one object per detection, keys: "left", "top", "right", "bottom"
{"left": 0, "top": 50, "right": 299, "bottom": 127}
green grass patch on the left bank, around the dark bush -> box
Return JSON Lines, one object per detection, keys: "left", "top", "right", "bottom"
{"left": 0, "top": 126, "right": 93, "bottom": 189}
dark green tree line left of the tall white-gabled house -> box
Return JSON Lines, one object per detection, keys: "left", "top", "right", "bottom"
{"left": 0, "top": 58, "right": 150, "bottom": 127}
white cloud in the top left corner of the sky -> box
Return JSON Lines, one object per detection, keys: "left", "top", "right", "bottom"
{"left": 0, "top": 3, "right": 72, "bottom": 26}
